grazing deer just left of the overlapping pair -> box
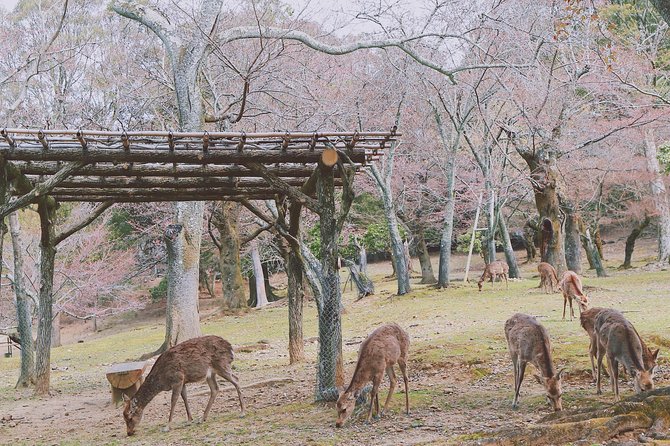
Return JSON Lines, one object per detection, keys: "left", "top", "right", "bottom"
{"left": 505, "top": 313, "right": 565, "bottom": 411}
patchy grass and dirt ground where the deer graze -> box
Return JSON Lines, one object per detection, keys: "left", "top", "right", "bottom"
{"left": 0, "top": 235, "right": 670, "bottom": 445}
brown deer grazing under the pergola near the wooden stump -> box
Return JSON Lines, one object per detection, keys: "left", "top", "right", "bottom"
{"left": 123, "top": 336, "right": 244, "bottom": 435}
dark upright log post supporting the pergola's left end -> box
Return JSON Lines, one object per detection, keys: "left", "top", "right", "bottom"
{"left": 35, "top": 197, "right": 56, "bottom": 395}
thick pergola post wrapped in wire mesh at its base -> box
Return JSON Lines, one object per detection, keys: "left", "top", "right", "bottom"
{"left": 316, "top": 166, "right": 344, "bottom": 401}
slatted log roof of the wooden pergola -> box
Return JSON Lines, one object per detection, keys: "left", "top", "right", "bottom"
{"left": 0, "top": 129, "right": 398, "bottom": 204}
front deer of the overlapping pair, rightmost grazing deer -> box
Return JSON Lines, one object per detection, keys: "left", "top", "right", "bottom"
{"left": 595, "top": 309, "right": 658, "bottom": 401}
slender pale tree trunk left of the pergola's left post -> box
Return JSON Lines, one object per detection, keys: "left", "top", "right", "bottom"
{"left": 8, "top": 212, "right": 35, "bottom": 388}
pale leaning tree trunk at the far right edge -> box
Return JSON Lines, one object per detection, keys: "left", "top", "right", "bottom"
{"left": 644, "top": 131, "right": 670, "bottom": 263}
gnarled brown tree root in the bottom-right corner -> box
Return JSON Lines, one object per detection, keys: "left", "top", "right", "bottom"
{"left": 478, "top": 387, "right": 670, "bottom": 445}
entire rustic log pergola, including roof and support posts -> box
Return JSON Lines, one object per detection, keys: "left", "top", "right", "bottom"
{"left": 0, "top": 127, "right": 400, "bottom": 396}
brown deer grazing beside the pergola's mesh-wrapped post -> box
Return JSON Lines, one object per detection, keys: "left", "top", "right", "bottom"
{"left": 335, "top": 324, "right": 409, "bottom": 427}
